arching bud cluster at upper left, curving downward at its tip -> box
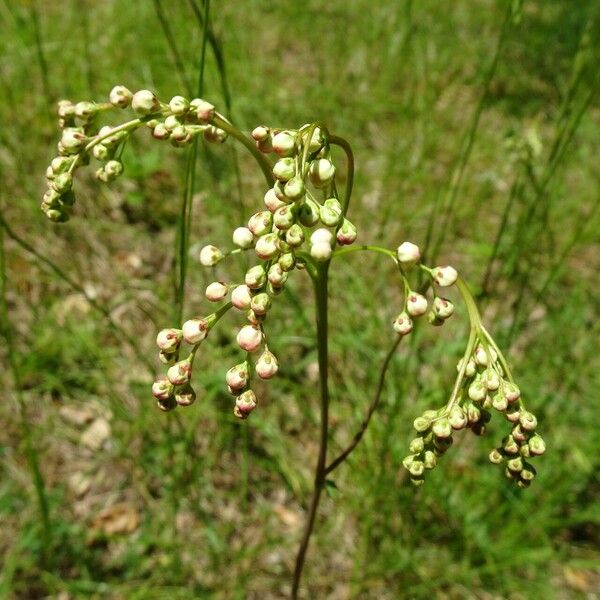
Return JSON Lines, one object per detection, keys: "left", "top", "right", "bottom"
{"left": 41, "top": 85, "right": 227, "bottom": 223}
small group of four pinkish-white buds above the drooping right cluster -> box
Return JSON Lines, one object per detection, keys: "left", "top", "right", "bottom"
{"left": 392, "top": 242, "right": 458, "bottom": 336}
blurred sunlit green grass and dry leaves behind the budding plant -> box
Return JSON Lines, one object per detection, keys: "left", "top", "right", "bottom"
{"left": 0, "top": 0, "right": 600, "bottom": 600}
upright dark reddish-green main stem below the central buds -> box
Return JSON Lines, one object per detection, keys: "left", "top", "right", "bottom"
{"left": 291, "top": 262, "right": 329, "bottom": 600}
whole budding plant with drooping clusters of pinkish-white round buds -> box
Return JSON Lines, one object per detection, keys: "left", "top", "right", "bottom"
{"left": 42, "top": 85, "right": 545, "bottom": 598}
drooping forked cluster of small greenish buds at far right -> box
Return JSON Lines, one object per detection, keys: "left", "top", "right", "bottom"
{"left": 403, "top": 332, "right": 546, "bottom": 487}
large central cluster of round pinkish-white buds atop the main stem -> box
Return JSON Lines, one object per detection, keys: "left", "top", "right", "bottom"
{"left": 154, "top": 117, "right": 356, "bottom": 419}
